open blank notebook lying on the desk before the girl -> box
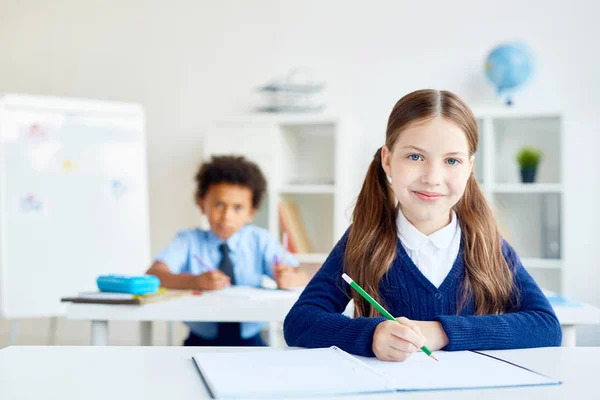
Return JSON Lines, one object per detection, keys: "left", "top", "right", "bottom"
{"left": 194, "top": 347, "right": 560, "bottom": 399}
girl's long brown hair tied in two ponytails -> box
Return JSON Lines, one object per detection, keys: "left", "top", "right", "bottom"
{"left": 344, "top": 90, "right": 514, "bottom": 317}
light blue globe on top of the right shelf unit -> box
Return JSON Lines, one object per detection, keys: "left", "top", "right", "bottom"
{"left": 485, "top": 43, "right": 533, "bottom": 105}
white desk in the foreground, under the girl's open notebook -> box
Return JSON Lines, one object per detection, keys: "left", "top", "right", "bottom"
{"left": 0, "top": 346, "right": 600, "bottom": 400}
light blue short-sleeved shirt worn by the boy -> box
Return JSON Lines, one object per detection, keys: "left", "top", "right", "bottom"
{"left": 156, "top": 225, "right": 298, "bottom": 340}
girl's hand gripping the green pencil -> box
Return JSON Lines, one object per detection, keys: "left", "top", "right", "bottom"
{"left": 372, "top": 317, "right": 426, "bottom": 361}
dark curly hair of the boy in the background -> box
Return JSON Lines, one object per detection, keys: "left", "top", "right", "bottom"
{"left": 196, "top": 156, "right": 267, "bottom": 209}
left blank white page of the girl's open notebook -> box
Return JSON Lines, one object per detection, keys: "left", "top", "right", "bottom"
{"left": 194, "top": 348, "right": 389, "bottom": 399}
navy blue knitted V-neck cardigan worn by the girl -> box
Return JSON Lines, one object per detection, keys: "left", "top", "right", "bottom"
{"left": 283, "top": 233, "right": 562, "bottom": 357}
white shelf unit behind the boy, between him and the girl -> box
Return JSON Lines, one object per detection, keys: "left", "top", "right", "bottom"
{"left": 204, "top": 114, "right": 358, "bottom": 264}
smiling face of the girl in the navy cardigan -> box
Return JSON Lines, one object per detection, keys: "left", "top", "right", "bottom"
{"left": 381, "top": 118, "right": 473, "bottom": 235}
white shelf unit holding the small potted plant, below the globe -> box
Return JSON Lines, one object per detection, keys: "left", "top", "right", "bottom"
{"left": 473, "top": 108, "right": 567, "bottom": 292}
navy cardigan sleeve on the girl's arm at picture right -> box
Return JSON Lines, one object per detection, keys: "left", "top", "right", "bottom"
{"left": 436, "top": 241, "right": 562, "bottom": 350}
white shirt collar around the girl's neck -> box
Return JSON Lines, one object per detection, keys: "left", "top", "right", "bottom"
{"left": 396, "top": 207, "right": 458, "bottom": 250}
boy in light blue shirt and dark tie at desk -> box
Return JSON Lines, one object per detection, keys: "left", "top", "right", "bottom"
{"left": 147, "top": 156, "right": 308, "bottom": 346}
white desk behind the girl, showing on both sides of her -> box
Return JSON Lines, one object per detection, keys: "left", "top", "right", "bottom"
{"left": 67, "top": 290, "right": 600, "bottom": 347}
